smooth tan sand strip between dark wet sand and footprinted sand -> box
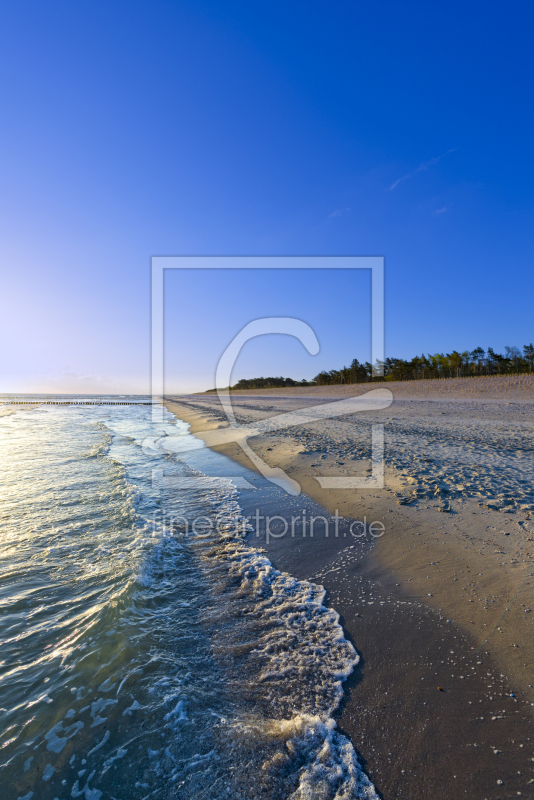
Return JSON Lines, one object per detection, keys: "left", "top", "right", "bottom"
{"left": 166, "top": 387, "right": 534, "bottom": 703}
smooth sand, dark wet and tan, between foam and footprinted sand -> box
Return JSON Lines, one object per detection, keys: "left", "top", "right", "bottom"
{"left": 165, "top": 382, "right": 534, "bottom": 800}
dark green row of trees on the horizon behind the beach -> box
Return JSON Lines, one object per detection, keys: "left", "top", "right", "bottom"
{"left": 224, "top": 343, "right": 534, "bottom": 389}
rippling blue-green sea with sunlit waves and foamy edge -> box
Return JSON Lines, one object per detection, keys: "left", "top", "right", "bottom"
{"left": 0, "top": 397, "right": 378, "bottom": 800}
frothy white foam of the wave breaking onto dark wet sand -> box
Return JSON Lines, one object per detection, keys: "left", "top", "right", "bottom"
{"left": 161, "top": 466, "right": 378, "bottom": 800}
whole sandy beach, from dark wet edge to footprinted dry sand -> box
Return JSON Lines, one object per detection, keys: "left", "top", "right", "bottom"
{"left": 166, "top": 375, "right": 534, "bottom": 800}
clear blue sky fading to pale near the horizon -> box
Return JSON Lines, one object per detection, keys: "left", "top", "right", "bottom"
{"left": 0, "top": 0, "right": 534, "bottom": 392}
